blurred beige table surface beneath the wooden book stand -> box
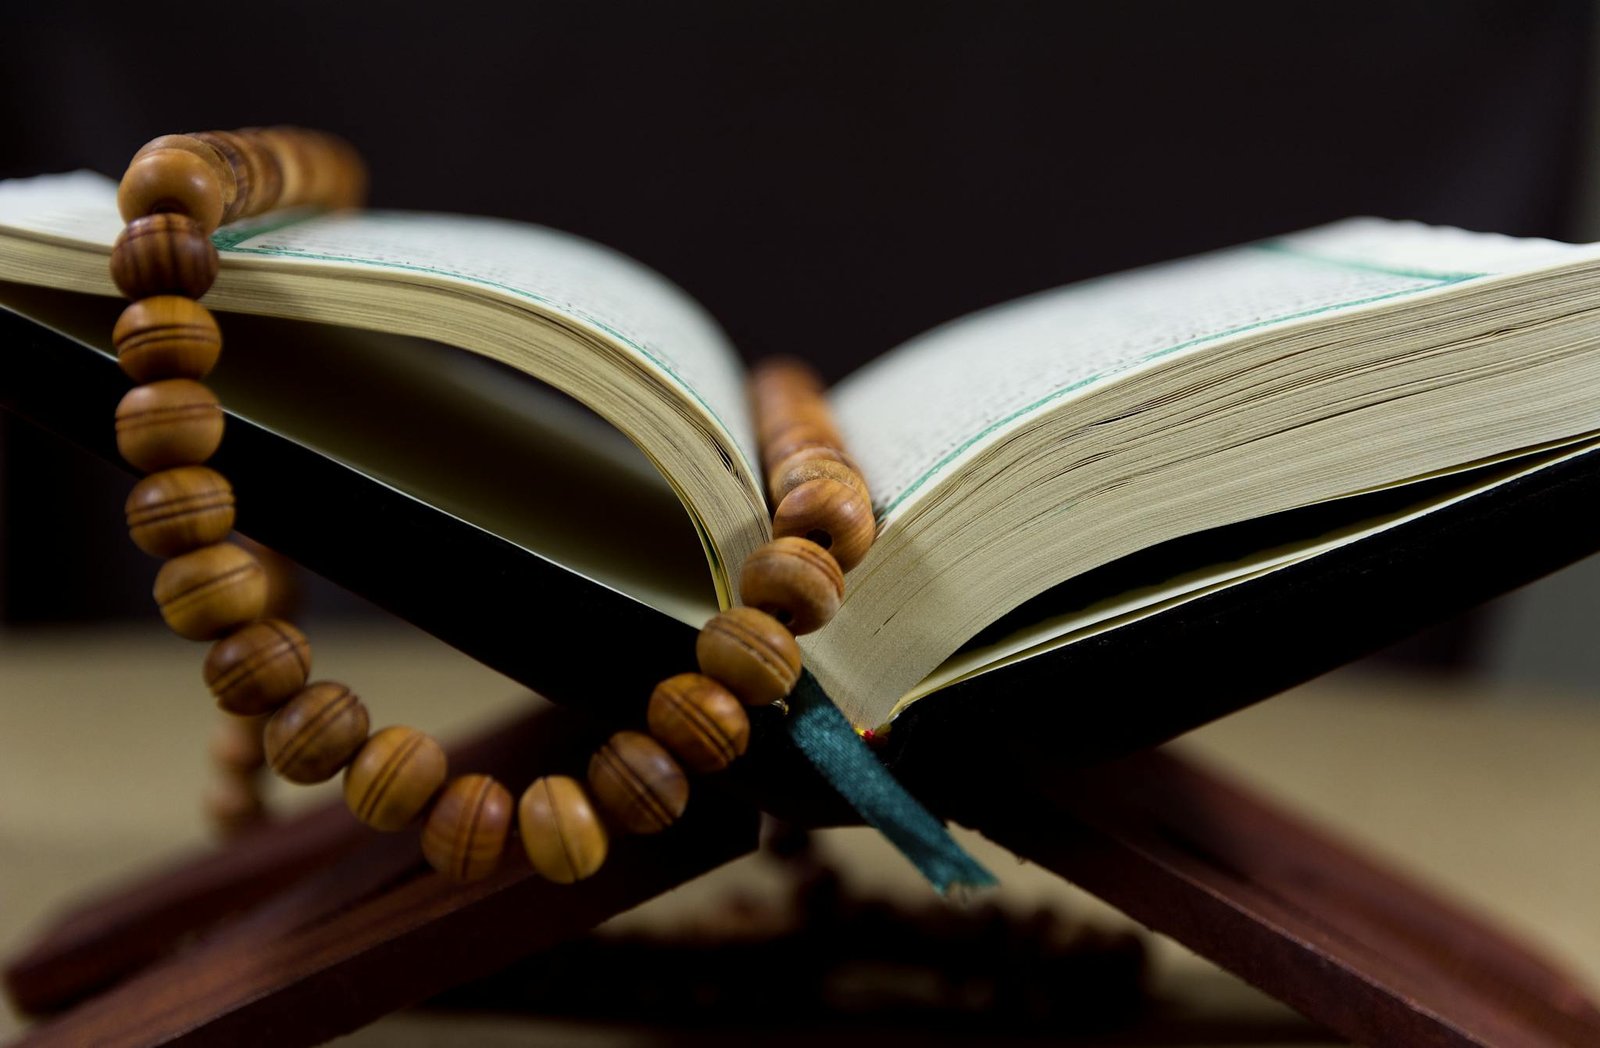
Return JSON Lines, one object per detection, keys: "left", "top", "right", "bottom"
{"left": 0, "top": 622, "right": 1600, "bottom": 1046}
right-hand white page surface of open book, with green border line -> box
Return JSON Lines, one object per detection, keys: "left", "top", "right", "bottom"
{"left": 832, "top": 219, "right": 1595, "bottom": 522}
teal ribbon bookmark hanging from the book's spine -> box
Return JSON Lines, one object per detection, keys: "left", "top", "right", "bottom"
{"left": 784, "top": 670, "right": 997, "bottom": 894}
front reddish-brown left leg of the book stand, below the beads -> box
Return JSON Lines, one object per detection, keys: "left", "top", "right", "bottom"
{"left": 7, "top": 777, "right": 757, "bottom": 1048}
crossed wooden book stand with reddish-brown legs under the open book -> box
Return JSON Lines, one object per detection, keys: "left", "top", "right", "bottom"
{"left": 0, "top": 305, "right": 1600, "bottom": 1046}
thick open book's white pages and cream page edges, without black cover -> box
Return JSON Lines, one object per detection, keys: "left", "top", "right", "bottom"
{"left": 0, "top": 173, "right": 1600, "bottom": 725}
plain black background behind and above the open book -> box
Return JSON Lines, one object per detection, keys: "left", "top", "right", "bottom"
{"left": 0, "top": 0, "right": 1594, "bottom": 640}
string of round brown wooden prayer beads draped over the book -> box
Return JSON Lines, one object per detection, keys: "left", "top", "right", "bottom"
{"left": 110, "top": 128, "right": 875, "bottom": 883}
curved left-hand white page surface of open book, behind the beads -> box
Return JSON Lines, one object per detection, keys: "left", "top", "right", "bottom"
{"left": 0, "top": 171, "right": 757, "bottom": 474}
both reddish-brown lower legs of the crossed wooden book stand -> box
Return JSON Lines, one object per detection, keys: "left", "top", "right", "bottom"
{"left": 8, "top": 694, "right": 1600, "bottom": 1048}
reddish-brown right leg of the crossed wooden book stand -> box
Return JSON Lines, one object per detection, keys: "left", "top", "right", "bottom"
{"left": 974, "top": 752, "right": 1600, "bottom": 1048}
